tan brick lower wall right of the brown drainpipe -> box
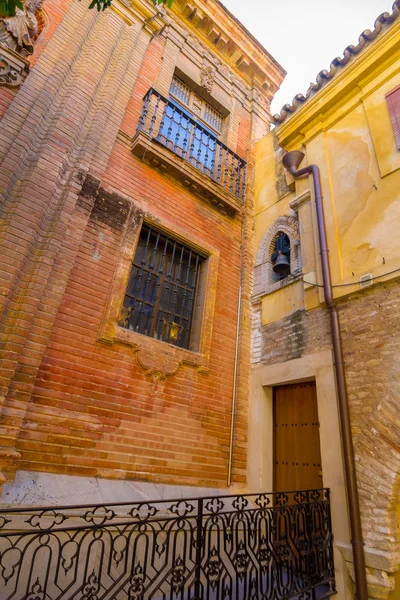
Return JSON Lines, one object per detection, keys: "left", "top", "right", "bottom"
{"left": 340, "top": 280, "right": 400, "bottom": 552}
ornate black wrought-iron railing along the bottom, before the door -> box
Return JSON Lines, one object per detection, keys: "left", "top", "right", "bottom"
{"left": 0, "top": 489, "right": 335, "bottom": 600}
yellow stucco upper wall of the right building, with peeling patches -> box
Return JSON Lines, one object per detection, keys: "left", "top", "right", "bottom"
{"left": 255, "top": 18, "right": 400, "bottom": 323}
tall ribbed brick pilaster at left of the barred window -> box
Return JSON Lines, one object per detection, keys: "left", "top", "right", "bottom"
{"left": 0, "top": 2, "right": 155, "bottom": 488}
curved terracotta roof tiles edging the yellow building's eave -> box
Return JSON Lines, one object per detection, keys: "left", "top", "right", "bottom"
{"left": 272, "top": 0, "right": 400, "bottom": 125}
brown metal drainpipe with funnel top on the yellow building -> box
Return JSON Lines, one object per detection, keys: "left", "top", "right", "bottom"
{"left": 282, "top": 150, "right": 368, "bottom": 600}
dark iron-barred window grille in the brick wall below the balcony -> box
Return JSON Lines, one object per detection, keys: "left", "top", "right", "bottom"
{"left": 119, "top": 224, "right": 205, "bottom": 348}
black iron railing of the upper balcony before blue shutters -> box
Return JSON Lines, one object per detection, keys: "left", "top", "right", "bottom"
{"left": 138, "top": 88, "right": 246, "bottom": 200}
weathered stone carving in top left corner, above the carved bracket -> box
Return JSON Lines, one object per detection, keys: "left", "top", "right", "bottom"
{"left": 0, "top": 0, "right": 43, "bottom": 57}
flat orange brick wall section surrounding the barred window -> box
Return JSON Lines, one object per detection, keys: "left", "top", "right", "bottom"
{"left": 17, "top": 143, "right": 247, "bottom": 485}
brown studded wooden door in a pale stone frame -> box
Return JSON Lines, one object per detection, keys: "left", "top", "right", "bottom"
{"left": 274, "top": 382, "right": 322, "bottom": 492}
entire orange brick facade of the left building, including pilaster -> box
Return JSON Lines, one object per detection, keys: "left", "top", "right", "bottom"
{"left": 0, "top": 2, "right": 282, "bottom": 487}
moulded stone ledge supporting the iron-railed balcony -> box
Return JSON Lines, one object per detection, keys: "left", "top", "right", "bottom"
{"left": 131, "top": 131, "right": 243, "bottom": 216}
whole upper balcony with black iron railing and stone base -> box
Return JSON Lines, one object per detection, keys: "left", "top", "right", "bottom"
{"left": 132, "top": 88, "right": 246, "bottom": 214}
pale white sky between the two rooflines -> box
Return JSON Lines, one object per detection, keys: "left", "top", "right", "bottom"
{"left": 222, "top": 0, "right": 394, "bottom": 114}
